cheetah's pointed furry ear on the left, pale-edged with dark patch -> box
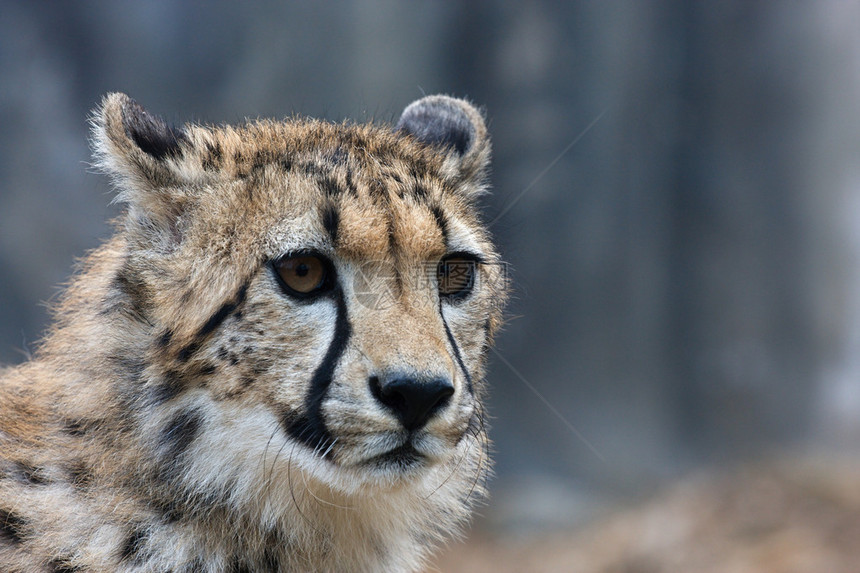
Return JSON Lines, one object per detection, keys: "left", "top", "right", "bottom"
{"left": 92, "top": 93, "right": 197, "bottom": 244}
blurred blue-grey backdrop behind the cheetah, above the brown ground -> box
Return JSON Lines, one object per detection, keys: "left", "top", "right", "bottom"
{"left": 0, "top": 0, "right": 860, "bottom": 531}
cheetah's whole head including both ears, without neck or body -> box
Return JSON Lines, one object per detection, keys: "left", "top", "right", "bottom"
{"left": 95, "top": 95, "right": 505, "bottom": 489}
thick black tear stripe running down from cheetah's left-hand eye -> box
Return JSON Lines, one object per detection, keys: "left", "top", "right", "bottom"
{"left": 281, "top": 289, "right": 352, "bottom": 456}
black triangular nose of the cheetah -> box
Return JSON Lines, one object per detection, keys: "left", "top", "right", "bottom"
{"left": 370, "top": 376, "right": 454, "bottom": 430}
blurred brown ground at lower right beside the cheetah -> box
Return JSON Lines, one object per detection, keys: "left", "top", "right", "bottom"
{"left": 427, "top": 459, "right": 860, "bottom": 573}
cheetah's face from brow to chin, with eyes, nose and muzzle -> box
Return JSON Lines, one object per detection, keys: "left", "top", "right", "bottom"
{"left": 258, "top": 208, "right": 497, "bottom": 477}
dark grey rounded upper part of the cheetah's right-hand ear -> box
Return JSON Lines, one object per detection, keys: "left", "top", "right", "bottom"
{"left": 395, "top": 96, "right": 476, "bottom": 156}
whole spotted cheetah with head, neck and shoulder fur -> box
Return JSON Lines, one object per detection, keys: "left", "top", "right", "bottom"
{"left": 0, "top": 93, "right": 507, "bottom": 573}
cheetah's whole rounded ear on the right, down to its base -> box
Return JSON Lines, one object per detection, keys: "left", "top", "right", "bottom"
{"left": 394, "top": 95, "right": 490, "bottom": 190}
